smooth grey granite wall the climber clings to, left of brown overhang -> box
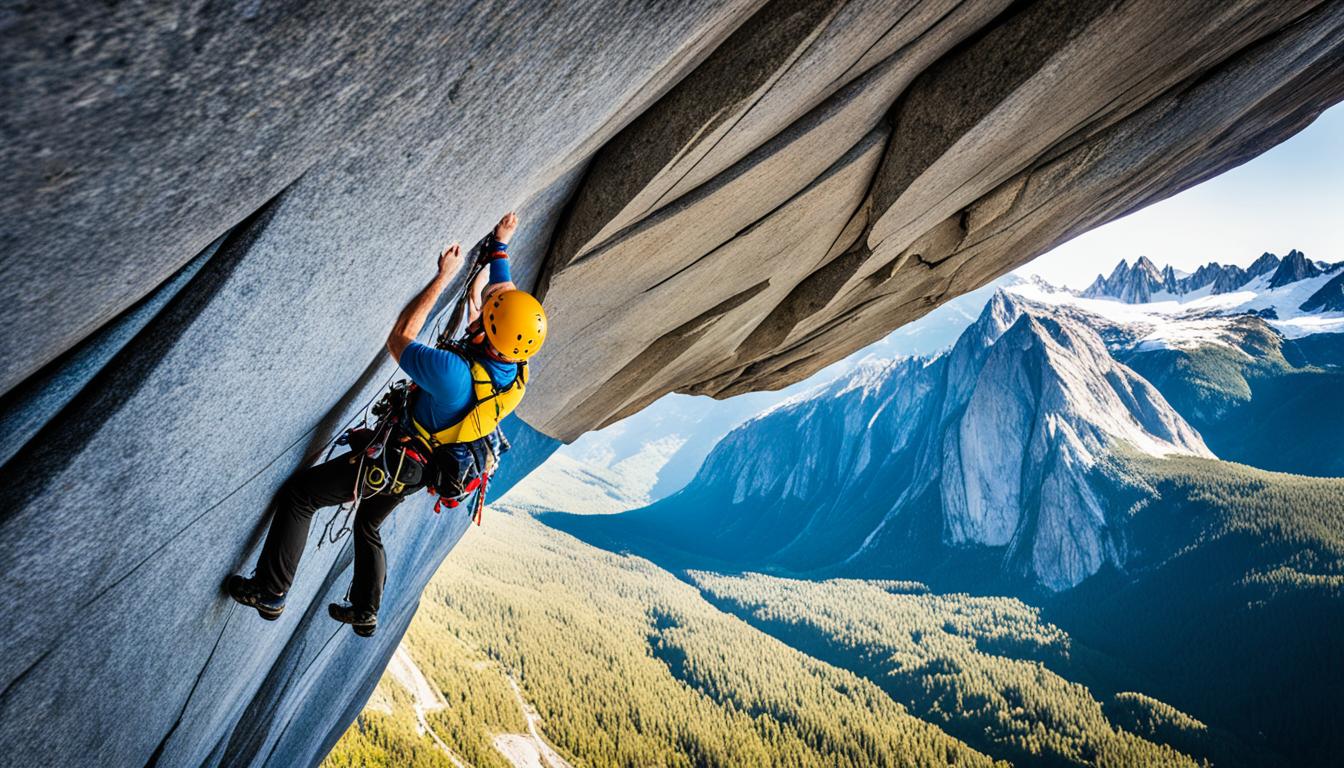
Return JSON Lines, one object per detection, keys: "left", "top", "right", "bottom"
{"left": 0, "top": 3, "right": 751, "bottom": 767}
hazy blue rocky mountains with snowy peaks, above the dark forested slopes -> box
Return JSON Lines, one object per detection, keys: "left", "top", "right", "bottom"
{"left": 548, "top": 250, "right": 1344, "bottom": 592}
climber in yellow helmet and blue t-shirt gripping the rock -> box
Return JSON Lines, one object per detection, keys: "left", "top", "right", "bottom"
{"left": 227, "top": 213, "right": 546, "bottom": 636}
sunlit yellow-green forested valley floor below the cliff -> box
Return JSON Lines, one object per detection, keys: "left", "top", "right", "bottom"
{"left": 324, "top": 504, "right": 1210, "bottom": 768}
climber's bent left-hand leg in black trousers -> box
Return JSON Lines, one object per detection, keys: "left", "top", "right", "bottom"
{"left": 255, "top": 453, "right": 362, "bottom": 597}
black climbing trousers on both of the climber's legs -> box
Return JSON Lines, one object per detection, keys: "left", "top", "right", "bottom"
{"left": 257, "top": 453, "right": 405, "bottom": 613}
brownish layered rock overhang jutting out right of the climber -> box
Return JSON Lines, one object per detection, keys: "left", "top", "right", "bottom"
{"left": 524, "top": 1, "right": 1344, "bottom": 438}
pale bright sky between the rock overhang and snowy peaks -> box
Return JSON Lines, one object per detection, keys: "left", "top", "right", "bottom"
{"left": 1017, "top": 105, "right": 1344, "bottom": 288}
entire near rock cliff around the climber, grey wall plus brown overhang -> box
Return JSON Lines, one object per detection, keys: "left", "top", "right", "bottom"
{"left": 0, "top": 0, "right": 1344, "bottom": 765}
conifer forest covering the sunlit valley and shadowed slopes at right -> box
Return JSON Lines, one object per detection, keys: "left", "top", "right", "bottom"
{"left": 325, "top": 456, "right": 1344, "bottom": 768}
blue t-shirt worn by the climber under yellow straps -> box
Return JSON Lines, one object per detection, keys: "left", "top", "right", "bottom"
{"left": 401, "top": 342, "right": 517, "bottom": 432}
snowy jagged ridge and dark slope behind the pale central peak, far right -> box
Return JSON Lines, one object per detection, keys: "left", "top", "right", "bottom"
{"left": 1012, "top": 277, "right": 1344, "bottom": 477}
